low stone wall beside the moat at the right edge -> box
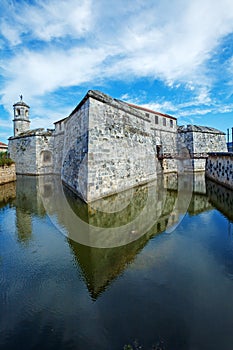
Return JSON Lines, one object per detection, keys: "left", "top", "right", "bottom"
{"left": 206, "top": 152, "right": 233, "bottom": 189}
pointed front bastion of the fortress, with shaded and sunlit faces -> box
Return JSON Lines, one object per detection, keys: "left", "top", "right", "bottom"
{"left": 62, "top": 96, "right": 179, "bottom": 202}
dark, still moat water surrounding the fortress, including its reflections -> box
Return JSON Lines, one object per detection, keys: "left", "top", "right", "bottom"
{"left": 0, "top": 175, "right": 233, "bottom": 350}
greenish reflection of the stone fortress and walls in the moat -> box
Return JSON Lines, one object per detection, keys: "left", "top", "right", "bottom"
{"left": 0, "top": 174, "right": 233, "bottom": 299}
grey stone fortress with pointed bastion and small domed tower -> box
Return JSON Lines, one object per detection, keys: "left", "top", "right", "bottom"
{"left": 8, "top": 90, "right": 227, "bottom": 202}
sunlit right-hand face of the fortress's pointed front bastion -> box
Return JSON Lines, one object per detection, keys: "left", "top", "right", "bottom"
{"left": 87, "top": 98, "right": 159, "bottom": 201}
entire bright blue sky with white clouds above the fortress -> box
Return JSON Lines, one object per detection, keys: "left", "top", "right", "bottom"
{"left": 0, "top": 0, "right": 233, "bottom": 142}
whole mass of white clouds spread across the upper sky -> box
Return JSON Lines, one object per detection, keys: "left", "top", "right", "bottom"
{"left": 0, "top": 0, "right": 233, "bottom": 126}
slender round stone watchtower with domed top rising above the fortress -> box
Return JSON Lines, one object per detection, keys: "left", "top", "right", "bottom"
{"left": 13, "top": 95, "right": 30, "bottom": 136}
